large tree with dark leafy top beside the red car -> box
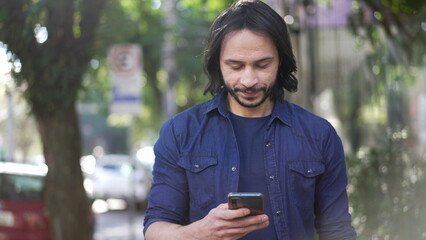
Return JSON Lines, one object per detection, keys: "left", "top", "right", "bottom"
{"left": 0, "top": 0, "right": 105, "bottom": 240}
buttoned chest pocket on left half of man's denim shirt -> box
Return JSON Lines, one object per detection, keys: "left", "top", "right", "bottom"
{"left": 178, "top": 155, "right": 218, "bottom": 208}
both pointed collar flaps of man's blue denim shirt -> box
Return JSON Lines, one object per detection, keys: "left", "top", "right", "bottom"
{"left": 204, "top": 90, "right": 293, "bottom": 126}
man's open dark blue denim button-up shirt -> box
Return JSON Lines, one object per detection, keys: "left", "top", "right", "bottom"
{"left": 144, "top": 92, "right": 356, "bottom": 240}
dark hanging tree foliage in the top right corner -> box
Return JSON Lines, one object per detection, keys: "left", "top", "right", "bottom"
{"left": 351, "top": 0, "right": 426, "bottom": 66}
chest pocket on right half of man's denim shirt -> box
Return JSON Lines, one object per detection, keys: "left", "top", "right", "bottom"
{"left": 288, "top": 161, "right": 325, "bottom": 212}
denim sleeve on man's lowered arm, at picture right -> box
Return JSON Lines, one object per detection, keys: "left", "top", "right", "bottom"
{"left": 315, "top": 125, "right": 356, "bottom": 240}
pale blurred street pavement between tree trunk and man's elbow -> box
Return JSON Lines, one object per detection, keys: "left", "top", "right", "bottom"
{"left": 94, "top": 209, "right": 144, "bottom": 240}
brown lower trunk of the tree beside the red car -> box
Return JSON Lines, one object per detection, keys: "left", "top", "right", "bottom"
{"left": 35, "top": 107, "right": 93, "bottom": 240}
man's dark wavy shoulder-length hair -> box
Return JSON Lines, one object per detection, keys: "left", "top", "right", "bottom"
{"left": 204, "top": 1, "right": 297, "bottom": 100}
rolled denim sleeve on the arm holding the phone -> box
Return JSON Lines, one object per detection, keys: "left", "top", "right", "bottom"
{"left": 144, "top": 119, "right": 189, "bottom": 233}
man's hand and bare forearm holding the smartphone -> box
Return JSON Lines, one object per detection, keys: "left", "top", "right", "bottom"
{"left": 145, "top": 203, "right": 269, "bottom": 240}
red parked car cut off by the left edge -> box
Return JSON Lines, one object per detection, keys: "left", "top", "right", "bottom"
{"left": 0, "top": 162, "right": 50, "bottom": 240}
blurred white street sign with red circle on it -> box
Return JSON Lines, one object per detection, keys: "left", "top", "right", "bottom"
{"left": 108, "top": 44, "right": 142, "bottom": 115}
